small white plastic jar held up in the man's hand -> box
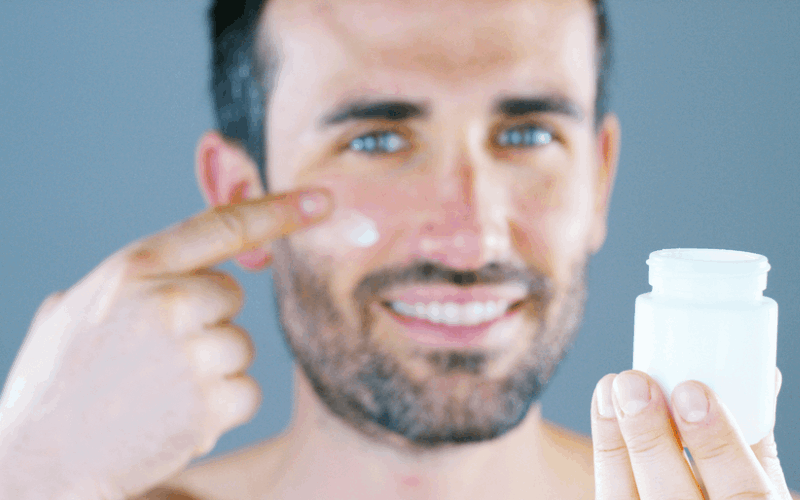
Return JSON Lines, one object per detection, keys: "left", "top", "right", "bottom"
{"left": 633, "top": 248, "right": 778, "bottom": 445}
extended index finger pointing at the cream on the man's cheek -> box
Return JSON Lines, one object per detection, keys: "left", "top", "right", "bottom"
{"left": 130, "top": 188, "right": 333, "bottom": 277}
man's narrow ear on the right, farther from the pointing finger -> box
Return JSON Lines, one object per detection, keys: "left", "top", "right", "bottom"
{"left": 589, "top": 113, "right": 620, "bottom": 254}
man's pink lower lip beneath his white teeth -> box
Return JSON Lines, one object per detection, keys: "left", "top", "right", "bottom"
{"left": 379, "top": 304, "right": 521, "bottom": 347}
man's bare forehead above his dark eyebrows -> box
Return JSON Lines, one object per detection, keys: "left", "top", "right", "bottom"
{"left": 262, "top": 0, "right": 596, "bottom": 106}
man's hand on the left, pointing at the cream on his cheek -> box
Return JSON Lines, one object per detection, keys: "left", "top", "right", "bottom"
{"left": 0, "top": 190, "right": 332, "bottom": 500}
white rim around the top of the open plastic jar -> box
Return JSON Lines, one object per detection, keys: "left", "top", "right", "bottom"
{"left": 647, "top": 248, "right": 771, "bottom": 276}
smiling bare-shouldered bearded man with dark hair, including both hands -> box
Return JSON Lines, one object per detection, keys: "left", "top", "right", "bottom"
{"left": 0, "top": 0, "right": 791, "bottom": 500}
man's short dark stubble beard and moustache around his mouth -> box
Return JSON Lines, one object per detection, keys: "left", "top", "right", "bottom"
{"left": 272, "top": 238, "right": 587, "bottom": 450}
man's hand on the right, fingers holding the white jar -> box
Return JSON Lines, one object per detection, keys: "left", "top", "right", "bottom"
{"left": 592, "top": 369, "right": 792, "bottom": 500}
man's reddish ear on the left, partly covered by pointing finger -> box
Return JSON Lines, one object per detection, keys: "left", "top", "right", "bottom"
{"left": 195, "top": 131, "right": 269, "bottom": 271}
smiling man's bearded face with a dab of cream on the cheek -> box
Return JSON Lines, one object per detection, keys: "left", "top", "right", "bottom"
{"left": 264, "top": 0, "right": 606, "bottom": 447}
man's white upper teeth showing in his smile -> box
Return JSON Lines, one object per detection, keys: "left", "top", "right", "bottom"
{"left": 391, "top": 300, "right": 509, "bottom": 325}
